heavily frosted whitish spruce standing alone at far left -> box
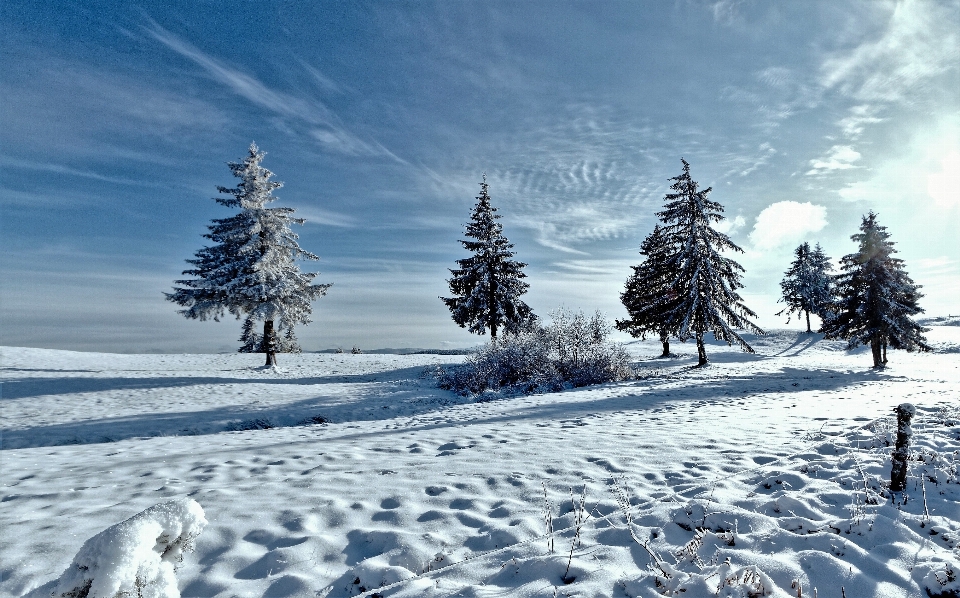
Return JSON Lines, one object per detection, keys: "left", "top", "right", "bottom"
{"left": 165, "top": 143, "right": 330, "bottom": 366}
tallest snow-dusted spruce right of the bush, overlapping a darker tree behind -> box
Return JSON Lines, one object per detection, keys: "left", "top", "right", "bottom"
{"left": 657, "top": 158, "right": 763, "bottom": 366}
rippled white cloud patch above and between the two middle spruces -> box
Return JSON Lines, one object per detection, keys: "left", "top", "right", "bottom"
{"left": 424, "top": 104, "right": 676, "bottom": 255}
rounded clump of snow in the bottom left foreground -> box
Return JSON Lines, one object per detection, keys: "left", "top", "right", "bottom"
{"left": 51, "top": 498, "right": 207, "bottom": 598}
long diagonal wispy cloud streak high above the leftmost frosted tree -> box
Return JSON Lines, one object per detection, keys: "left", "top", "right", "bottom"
{"left": 144, "top": 21, "right": 403, "bottom": 162}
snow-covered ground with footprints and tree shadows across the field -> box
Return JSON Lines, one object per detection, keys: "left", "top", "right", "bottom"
{"left": 0, "top": 326, "right": 960, "bottom": 598}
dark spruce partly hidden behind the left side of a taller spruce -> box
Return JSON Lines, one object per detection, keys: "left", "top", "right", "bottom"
{"left": 616, "top": 224, "right": 679, "bottom": 357}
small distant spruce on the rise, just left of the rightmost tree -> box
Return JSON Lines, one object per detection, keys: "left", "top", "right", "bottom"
{"left": 777, "top": 243, "right": 833, "bottom": 332}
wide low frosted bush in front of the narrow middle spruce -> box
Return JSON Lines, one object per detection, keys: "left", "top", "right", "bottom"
{"left": 437, "top": 309, "right": 633, "bottom": 395}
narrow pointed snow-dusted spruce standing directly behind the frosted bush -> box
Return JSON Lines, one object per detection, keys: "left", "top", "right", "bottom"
{"left": 440, "top": 175, "right": 535, "bottom": 340}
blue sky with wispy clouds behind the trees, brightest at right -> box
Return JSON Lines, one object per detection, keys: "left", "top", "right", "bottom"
{"left": 0, "top": 0, "right": 960, "bottom": 352}
